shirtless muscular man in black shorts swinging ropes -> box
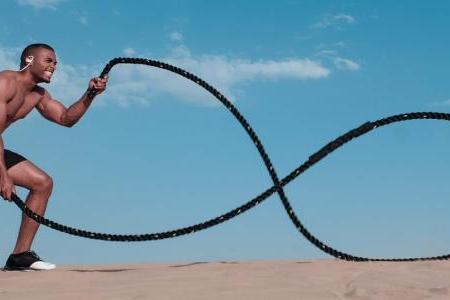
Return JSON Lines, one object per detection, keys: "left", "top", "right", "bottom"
{"left": 0, "top": 44, "right": 107, "bottom": 270}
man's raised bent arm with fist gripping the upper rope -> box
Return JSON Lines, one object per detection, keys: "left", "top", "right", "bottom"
{"left": 36, "top": 78, "right": 108, "bottom": 127}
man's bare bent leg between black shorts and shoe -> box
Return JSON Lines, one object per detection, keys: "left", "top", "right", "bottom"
{"left": 8, "top": 160, "right": 53, "bottom": 253}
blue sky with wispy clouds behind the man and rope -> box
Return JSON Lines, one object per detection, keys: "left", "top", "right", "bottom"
{"left": 0, "top": 0, "right": 450, "bottom": 264}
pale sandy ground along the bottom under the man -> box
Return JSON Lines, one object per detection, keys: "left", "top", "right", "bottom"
{"left": 0, "top": 260, "right": 450, "bottom": 300}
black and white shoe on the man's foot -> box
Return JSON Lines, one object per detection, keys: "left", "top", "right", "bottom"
{"left": 4, "top": 251, "right": 56, "bottom": 271}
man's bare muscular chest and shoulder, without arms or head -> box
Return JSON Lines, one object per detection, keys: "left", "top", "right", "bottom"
{"left": 0, "top": 72, "right": 44, "bottom": 127}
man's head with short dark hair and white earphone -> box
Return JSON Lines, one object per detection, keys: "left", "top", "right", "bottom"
{"left": 20, "top": 44, "right": 57, "bottom": 83}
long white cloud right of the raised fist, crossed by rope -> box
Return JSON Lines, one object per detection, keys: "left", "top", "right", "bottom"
{"left": 103, "top": 45, "right": 330, "bottom": 105}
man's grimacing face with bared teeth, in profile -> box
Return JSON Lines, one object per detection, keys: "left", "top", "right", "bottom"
{"left": 30, "top": 48, "right": 57, "bottom": 83}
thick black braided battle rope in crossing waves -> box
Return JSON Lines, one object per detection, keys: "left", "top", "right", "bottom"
{"left": 7, "top": 58, "right": 450, "bottom": 261}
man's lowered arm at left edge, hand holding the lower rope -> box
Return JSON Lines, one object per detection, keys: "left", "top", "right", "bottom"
{"left": 0, "top": 77, "right": 16, "bottom": 200}
